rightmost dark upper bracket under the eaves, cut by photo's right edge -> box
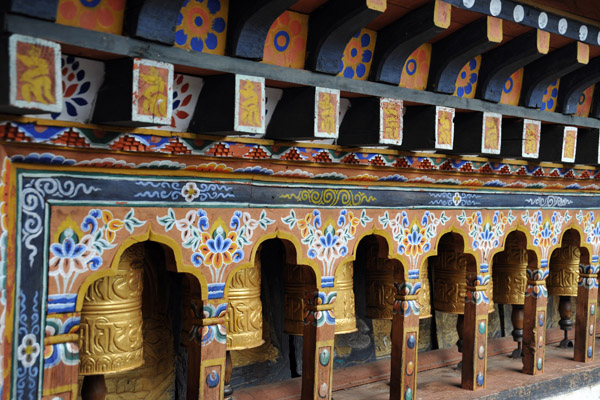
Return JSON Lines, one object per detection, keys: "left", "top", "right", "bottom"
{"left": 557, "top": 57, "right": 600, "bottom": 114}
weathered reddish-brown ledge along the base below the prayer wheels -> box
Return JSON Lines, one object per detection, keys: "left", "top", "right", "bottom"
{"left": 234, "top": 329, "right": 600, "bottom": 400}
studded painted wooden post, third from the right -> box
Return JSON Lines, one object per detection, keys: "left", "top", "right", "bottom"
{"left": 461, "top": 274, "right": 490, "bottom": 390}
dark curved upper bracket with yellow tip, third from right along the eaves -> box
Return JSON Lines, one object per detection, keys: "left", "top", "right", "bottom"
{"left": 477, "top": 30, "right": 550, "bottom": 103}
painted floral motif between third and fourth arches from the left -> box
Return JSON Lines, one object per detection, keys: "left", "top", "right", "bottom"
{"left": 379, "top": 211, "right": 450, "bottom": 269}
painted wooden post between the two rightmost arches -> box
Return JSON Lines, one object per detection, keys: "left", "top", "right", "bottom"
{"left": 523, "top": 259, "right": 548, "bottom": 375}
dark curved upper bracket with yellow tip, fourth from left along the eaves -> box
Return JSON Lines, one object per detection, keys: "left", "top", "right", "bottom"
{"left": 306, "top": 0, "right": 387, "bottom": 75}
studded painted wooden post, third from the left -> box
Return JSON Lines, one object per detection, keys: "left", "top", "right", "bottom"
{"left": 390, "top": 280, "right": 421, "bottom": 400}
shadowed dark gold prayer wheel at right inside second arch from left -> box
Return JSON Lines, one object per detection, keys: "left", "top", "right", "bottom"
{"left": 283, "top": 264, "right": 315, "bottom": 336}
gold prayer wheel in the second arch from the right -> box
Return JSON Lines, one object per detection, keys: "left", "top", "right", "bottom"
{"left": 492, "top": 235, "right": 528, "bottom": 304}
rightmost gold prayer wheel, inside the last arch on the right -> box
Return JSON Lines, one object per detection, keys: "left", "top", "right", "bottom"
{"left": 546, "top": 245, "right": 581, "bottom": 296}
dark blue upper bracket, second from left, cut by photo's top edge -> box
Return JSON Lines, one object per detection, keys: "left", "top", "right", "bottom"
{"left": 127, "top": 0, "right": 188, "bottom": 45}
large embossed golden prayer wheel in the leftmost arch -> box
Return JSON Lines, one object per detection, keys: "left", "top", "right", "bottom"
{"left": 79, "top": 247, "right": 144, "bottom": 375}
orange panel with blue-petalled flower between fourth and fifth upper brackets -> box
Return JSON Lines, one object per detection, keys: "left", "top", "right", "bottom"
{"left": 338, "top": 29, "right": 377, "bottom": 80}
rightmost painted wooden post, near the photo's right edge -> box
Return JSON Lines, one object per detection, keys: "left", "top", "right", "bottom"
{"left": 573, "top": 265, "right": 600, "bottom": 362}
